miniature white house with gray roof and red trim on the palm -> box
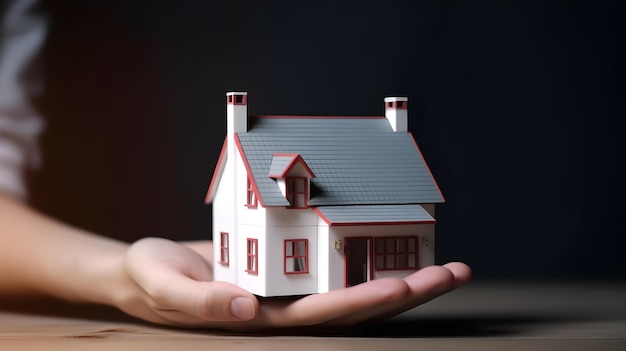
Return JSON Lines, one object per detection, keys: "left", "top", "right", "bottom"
{"left": 206, "top": 92, "right": 444, "bottom": 296}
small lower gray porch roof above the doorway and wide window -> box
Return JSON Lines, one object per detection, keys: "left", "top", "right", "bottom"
{"left": 317, "top": 205, "right": 435, "bottom": 225}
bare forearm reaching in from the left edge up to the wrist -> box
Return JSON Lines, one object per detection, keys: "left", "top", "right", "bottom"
{"left": 0, "top": 193, "right": 130, "bottom": 305}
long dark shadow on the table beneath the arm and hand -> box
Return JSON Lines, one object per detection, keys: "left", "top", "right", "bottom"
{"left": 0, "top": 299, "right": 604, "bottom": 338}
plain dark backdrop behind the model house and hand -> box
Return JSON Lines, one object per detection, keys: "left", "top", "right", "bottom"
{"left": 30, "top": 0, "right": 626, "bottom": 279}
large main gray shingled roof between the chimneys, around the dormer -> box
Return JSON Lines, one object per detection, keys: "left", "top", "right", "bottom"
{"left": 238, "top": 117, "right": 444, "bottom": 206}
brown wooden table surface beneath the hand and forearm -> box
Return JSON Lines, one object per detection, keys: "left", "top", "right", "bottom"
{"left": 0, "top": 281, "right": 626, "bottom": 351}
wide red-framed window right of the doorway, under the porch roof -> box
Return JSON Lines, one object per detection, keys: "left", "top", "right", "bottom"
{"left": 374, "top": 236, "right": 417, "bottom": 271}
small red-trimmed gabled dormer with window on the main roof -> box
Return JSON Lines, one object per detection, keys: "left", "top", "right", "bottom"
{"left": 268, "top": 154, "right": 315, "bottom": 209}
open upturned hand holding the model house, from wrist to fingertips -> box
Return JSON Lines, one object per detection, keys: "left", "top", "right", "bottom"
{"left": 117, "top": 238, "right": 471, "bottom": 331}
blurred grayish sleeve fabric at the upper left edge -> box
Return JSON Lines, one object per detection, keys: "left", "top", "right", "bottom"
{"left": 0, "top": 0, "right": 47, "bottom": 198}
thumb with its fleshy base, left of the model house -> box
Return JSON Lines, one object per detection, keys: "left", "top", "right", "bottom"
{"left": 126, "top": 239, "right": 258, "bottom": 324}
